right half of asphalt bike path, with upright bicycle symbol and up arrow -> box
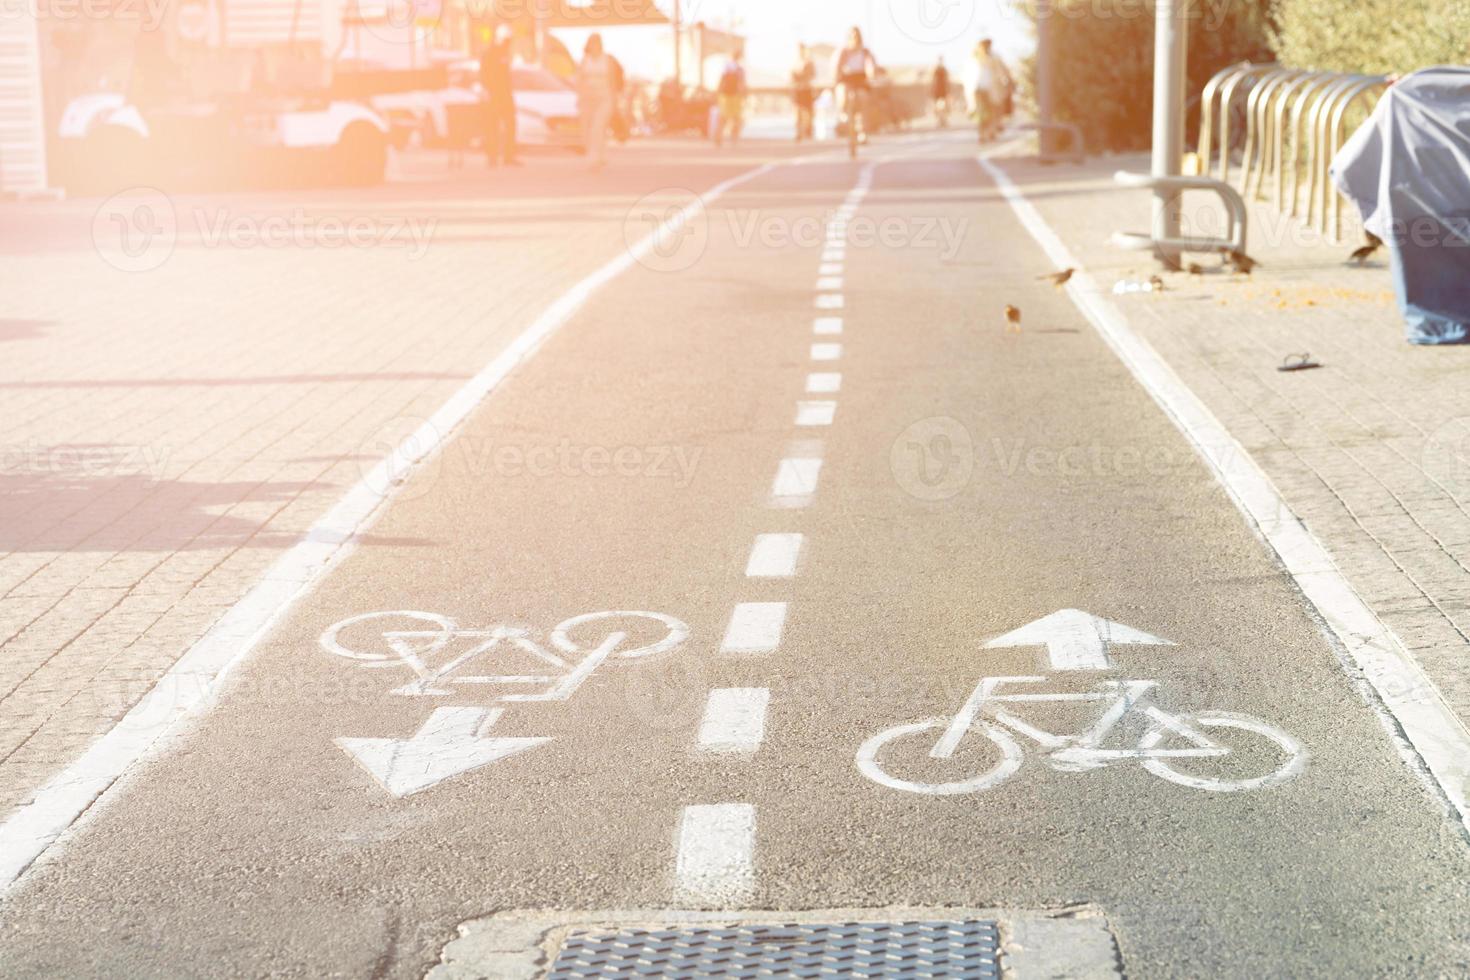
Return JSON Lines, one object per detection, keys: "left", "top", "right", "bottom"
{"left": 760, "top": 147, "right": 1470, "bottom": 976}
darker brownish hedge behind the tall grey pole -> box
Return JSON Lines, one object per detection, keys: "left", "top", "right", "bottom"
{"left": 1023, "top": 0, "right": 1275, "bottom": 150}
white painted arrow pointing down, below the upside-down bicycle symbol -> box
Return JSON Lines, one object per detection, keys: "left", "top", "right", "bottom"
{"left": 337, "top": 708, "right": 551, "bottom": 796}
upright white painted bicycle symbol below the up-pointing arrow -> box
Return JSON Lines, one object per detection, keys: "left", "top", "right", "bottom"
{"left": 857, "top": 677, "right": 1307, "bottom": 796}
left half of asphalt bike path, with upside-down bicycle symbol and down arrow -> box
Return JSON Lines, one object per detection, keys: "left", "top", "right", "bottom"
{"left": 0, "top": 147, "right": 934, "bottom": 976}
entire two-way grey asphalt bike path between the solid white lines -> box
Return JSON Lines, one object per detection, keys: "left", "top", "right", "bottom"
{"left": 0, "top": 134, "right": 1470, "bottom": 977}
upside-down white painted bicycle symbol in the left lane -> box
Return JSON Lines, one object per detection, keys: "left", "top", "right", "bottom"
{"left": 320, "top": 610, "right": 689, "bottom": 702}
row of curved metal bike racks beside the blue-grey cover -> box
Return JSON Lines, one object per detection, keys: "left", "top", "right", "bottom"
{"left": 1200, "top": 62, "right": 1388, "bottom": 242}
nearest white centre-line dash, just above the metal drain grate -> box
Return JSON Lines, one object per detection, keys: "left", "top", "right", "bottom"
{"left": 673, "top": 804, "right": 756, "bottom": 908}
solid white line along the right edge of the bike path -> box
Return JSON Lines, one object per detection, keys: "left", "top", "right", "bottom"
{"left": 979, "top": 157, "right": 1470, "bottom": 830}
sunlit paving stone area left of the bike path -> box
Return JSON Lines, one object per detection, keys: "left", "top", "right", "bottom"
{"left": 0, "top": 144, "right": 782, "bottom": 818}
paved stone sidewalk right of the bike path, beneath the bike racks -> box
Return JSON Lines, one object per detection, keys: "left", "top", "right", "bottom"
{"left": 1000, "top": 149, "right": 1470, "bottom": 723}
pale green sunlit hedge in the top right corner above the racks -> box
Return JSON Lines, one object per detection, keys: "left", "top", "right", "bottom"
{"left": 1273, "top": 0, "right": 1470, "bottom": 75}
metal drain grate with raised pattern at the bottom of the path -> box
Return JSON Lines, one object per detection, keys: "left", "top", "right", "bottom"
{"left": 550, "top": 921, "right": 1000, "bottom": 980}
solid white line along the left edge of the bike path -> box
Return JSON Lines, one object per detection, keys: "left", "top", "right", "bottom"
{"left": 0, "top": 153, "right": 799, "bottom": 892}
